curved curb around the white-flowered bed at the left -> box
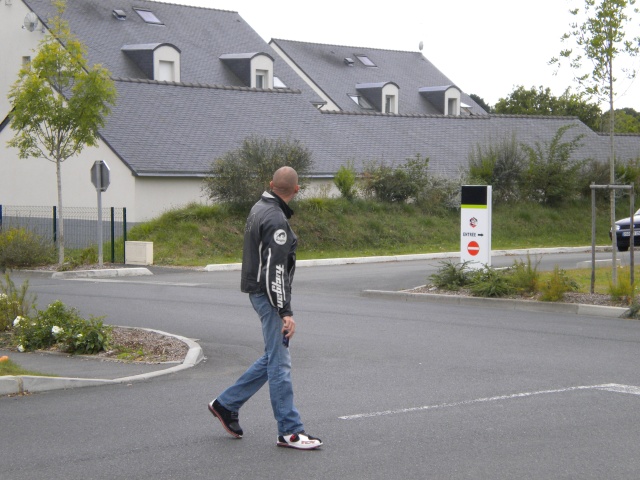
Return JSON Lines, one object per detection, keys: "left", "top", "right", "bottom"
{"left": 0, "top": 327, "right": 204, "bottom": 395}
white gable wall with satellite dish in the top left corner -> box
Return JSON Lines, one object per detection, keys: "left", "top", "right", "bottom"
{"left": 0, "top": 0, "right": 44, "bottom": 117}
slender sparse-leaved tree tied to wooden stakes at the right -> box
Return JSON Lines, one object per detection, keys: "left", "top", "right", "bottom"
{"left": 550, "top": 0, "right": 640, "bottom": 285}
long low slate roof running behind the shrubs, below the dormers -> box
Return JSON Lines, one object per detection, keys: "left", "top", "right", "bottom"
{"left": 101, "top": 79, "right": 640, "bottom": 178}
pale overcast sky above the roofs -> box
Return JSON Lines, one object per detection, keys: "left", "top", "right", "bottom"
{"left": 160, "top": 0, "right": 640, "bottom": 111}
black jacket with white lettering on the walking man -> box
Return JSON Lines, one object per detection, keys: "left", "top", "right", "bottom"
{"left": 240, "top": 192, "right": 298, "bottom": 317}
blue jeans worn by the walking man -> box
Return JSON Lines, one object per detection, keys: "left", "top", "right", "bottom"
{"left": 218, "top": 293, "right": 304, "bottom": 435}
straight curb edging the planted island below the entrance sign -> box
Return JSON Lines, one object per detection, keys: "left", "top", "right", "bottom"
{"left": 362, "top": 290, "right": 628, "bottom": 318}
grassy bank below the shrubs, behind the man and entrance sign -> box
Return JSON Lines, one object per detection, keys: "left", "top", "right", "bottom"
{"left": 128, "top": 198, "right": 628, "bottom": 266}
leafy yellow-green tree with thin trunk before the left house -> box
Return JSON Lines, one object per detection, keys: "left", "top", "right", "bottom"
{"left": 8, "top": 0, "right": 116, "bottom": 264}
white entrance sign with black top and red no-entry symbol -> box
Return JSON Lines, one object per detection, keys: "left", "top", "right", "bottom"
{"left": 460, "top": 185, "right": 491, "bottom": 270}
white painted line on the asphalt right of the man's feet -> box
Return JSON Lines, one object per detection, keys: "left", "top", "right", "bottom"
{"left": 338, "top": 383, "right": 640, "bottom": 420}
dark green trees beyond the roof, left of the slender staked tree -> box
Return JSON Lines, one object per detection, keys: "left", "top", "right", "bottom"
{"left": 494, "top": 85, "right": 602, "bottom": 130}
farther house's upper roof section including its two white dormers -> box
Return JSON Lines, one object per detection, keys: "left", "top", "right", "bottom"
{"left": 269, "top": 39, "right": 487, "bottom": 116}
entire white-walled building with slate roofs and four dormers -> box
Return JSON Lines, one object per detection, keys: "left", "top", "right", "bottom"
{"left": 0, "top": 0, "right": 640, "bottom": 222}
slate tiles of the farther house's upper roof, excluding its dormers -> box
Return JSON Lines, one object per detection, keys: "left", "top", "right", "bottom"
{"left": 271, "top": 39, "right": 487, "bottom": 115}
